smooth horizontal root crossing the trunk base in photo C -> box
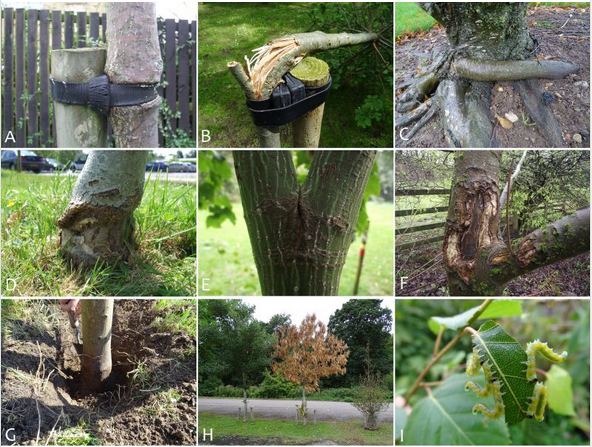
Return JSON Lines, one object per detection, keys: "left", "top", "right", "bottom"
{"left": 451, "top": 58, "right": 580, "bottom": 82}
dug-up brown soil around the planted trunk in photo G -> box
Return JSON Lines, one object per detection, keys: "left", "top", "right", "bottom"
{"left": 2, "top": 300, "right": 197, "bottom": 445}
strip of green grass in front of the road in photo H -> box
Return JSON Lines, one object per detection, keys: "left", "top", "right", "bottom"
{"left": 198, "top": 413, "right": 393, "bottom": 445}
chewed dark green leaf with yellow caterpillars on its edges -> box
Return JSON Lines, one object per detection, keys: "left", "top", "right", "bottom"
{"left": 473, "top": 320, "right": 534, "bottom": 424}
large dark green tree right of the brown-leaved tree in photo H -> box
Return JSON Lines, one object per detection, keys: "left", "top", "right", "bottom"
{"left": 323, "top": 300, "right": 393, "bottom": 387}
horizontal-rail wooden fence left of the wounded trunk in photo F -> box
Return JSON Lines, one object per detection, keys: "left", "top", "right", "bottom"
{"left": 395, "top": 189, "right": 450, "bottom": 251}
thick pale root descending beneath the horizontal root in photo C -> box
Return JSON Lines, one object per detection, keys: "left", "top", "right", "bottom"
{"left": 436, "top": 79, "right": 497, "bottom": 148}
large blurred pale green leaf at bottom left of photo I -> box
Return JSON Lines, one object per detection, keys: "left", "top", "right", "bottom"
{"left": 401, "top": 373, "right": 510, "bottom": 445}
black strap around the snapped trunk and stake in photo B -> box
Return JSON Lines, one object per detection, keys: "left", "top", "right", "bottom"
{"left": 247, "top": 73, "right": 332, "bottom": 127}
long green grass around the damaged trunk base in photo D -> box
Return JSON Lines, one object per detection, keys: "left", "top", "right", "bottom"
{"left": 1, "top": 170, "right": 197, "bottom": 296}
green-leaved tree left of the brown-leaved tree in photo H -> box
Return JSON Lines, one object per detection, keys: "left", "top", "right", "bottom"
{"left": 199, "top": 300, "right": 275, "bottom": 421}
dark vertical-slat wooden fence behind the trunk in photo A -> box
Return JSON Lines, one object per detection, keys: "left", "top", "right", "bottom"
{"left": 2, "top": 8, "right": 197, "bottom": 147}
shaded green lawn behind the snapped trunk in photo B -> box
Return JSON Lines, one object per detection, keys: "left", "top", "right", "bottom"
{"left": 198, "top": 2, "right": 393, "bottom": 148}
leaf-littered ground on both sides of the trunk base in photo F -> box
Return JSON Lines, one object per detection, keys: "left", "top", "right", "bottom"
{"left": 395, "top": 248, "right": 590, "bottom": 297}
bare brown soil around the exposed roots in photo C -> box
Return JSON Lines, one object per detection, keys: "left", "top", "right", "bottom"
{"left": 395, "top": 6, "right": 590, "bottom": 148}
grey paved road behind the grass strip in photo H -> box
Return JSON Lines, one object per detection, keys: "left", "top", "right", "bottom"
{"left": 197, "top": 397, "right": 393, "bottom": 422}
